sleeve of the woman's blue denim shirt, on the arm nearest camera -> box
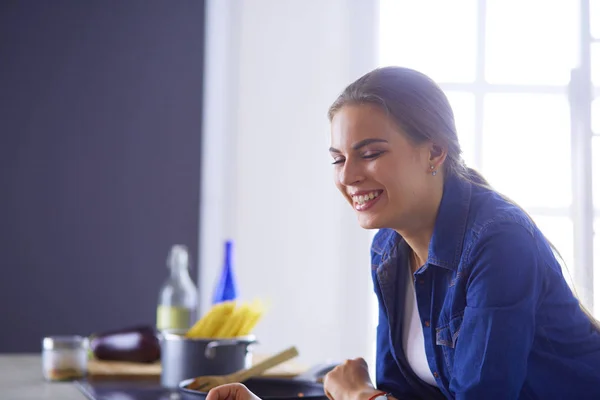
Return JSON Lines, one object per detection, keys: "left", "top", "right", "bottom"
{"left": 450, "top": 221, "right": 544, "bottom": 400}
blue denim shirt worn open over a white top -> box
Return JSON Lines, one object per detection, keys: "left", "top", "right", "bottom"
{"left": 371, "top": 173, "right": 600, "bottom": 400}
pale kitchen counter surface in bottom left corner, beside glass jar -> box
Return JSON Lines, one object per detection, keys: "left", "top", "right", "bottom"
{"left": 0, "top": 354, "right": 86, "bottom": 400}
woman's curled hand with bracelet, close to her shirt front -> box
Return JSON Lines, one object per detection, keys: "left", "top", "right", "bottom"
{"left": 323, "top": 358, "right": 379, "bottom": 400}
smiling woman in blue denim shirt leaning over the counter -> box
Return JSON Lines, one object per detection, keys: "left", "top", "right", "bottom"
{"left": 204, "top": 67, "right": 600, "bottom": 400}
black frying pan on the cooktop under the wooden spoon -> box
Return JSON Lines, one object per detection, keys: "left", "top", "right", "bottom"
{"left": 179, "top": 364, "right": 336, "bottom": 400}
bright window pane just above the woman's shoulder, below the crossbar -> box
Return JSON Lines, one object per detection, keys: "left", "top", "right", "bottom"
{"left": 482, "top": 93, "right": 571, "bottom": 208}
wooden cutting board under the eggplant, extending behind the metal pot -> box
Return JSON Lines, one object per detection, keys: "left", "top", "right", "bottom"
{"left": 88, "top": 354, "right": 307, "bottom": 381}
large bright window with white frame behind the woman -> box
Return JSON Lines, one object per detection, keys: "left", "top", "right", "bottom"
{"left": 379, "top": 0, "right": 600, "bottom": 317}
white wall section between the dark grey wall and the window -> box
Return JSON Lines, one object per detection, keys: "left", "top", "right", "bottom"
{"left": 199, "top": 0, "right": 377, "bottom": 364}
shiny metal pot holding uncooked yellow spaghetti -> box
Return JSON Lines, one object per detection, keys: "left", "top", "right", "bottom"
{"left": 160, "top": 331, "right": 256, "bottom": 388}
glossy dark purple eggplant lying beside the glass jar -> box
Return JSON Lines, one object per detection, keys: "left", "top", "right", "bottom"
{"left": 90, "top": 325, "right": 160, "bottom": 363}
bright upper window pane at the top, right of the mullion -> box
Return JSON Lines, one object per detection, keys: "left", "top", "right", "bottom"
{"left": 485, "top": 0, "right": 579, "bottom": 85}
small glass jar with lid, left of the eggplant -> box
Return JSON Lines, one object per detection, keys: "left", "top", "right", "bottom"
{"left": 42, "top": 335, "right": 89, "bottom": 381}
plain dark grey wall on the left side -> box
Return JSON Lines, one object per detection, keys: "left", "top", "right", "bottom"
{"left": 0, "top": 0, "right": 204, "bottom": 352}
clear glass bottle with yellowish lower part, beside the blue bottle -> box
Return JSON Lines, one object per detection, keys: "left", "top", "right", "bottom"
{"left": 156, "top": 245, "right": 198, "bottom": 331}
